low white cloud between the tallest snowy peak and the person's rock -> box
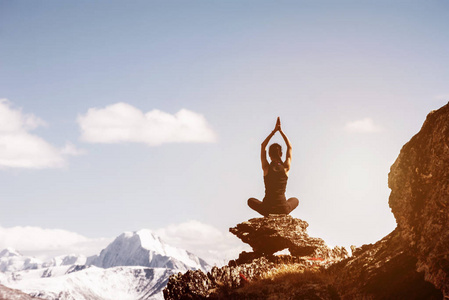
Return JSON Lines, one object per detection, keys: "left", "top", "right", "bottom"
{"left": 154, "top": 220, "right": 252, "bottom": 265}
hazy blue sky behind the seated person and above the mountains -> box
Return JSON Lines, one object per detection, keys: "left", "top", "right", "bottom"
{"left": 0, "top": 1, "right": 449, "bottom": 262}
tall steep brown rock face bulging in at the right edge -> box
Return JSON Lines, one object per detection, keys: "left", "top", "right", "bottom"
{"left": 388, "top": 104, "right": 449, "bottom": 297}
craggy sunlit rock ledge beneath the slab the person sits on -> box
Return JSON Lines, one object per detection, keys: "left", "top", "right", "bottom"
{"left": 164, "top": 255, "right": 339, "bottom": 300}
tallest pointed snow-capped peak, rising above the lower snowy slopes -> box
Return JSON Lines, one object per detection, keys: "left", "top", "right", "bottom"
{"left": 88, "top": 229, "right": 210, "bottom": 271}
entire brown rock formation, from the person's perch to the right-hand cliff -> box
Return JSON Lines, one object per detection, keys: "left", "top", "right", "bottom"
{"left": 164, "top": 104, "right": 449, "bottom": 299}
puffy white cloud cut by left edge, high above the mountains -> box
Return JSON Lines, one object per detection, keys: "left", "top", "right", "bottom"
{"left": 0, "top": 99, "right": 83, "bottom": 169}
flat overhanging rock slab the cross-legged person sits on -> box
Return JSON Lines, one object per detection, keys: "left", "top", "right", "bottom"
{"left": 229, "top": 215, "right": 348, "bottom": 259}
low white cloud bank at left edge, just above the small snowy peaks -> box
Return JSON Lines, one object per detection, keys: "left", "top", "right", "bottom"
{"left": 0, "top": 226, "right": 112, "bottom": 260}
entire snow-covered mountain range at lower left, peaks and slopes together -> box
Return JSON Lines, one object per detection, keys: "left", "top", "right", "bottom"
{"left": 0, "top": 230, "right": 210, "bottom": 300}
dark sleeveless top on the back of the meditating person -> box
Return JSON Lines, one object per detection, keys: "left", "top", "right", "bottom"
{"left": 263, "top": 162, "right": 288, "bottom": 206}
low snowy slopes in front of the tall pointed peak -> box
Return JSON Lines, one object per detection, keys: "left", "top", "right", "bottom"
{"left": 4, "top": 266, "right": 175, "bottom": 300}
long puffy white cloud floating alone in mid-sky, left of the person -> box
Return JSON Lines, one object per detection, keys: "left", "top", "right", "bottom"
{"left": 78, "top": 103, "right": 216, "bottom": 146}
